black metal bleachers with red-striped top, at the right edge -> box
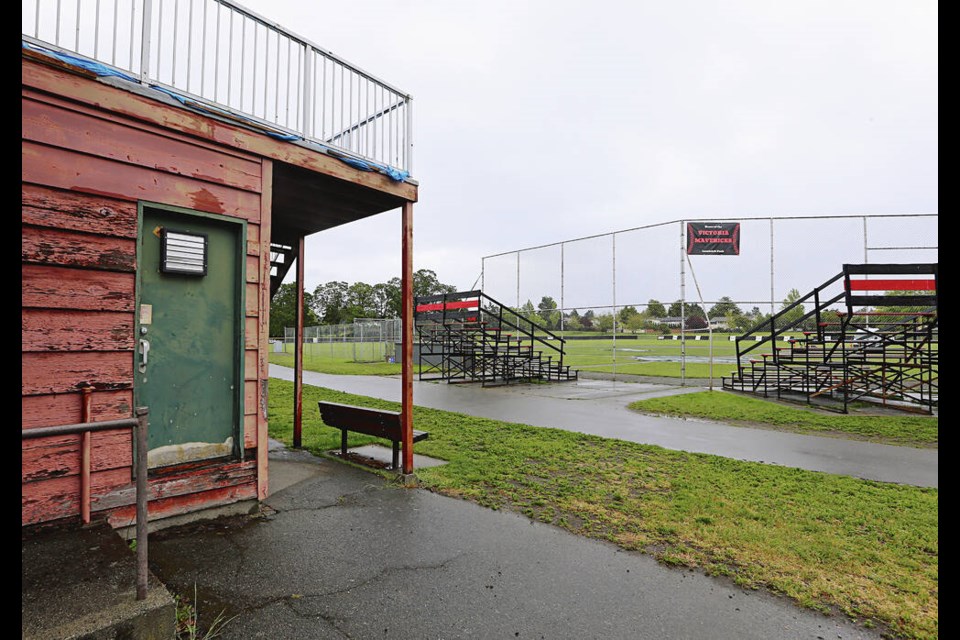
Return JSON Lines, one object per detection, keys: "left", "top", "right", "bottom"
{"left": 723, "top": 264, "right": 939, "bottom": 414}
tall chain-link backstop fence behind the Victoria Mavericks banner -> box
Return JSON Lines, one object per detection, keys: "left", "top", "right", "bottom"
{"left": 481, "top": 213, "right": 938, "bottom": 377}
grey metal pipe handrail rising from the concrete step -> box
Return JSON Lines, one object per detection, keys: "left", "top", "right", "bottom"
{"left": 20, "top": 407, "right": 149, "bottom": 600}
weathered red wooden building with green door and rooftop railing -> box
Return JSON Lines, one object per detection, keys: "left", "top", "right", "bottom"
{"left": 21, "top": 0, "right": 417, "bottom": 526}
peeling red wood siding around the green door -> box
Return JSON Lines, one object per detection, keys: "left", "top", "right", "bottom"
{"left": 21, "top": 61, "right": 269, "bottom": 525}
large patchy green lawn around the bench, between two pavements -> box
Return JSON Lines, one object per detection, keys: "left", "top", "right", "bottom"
{"left": 270, "top": 379, "right": 939, "bottom": 638}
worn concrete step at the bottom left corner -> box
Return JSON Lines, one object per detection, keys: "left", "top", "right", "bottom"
{"left": 21, "top": 523, "right": 176, "bottom": 640}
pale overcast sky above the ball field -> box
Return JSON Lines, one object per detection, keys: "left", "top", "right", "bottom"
{"left": 241, "top": 0, "right": 938, "bottom": 297}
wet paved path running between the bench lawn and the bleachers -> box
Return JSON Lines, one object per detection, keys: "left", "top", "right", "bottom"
{"left": 270, "top": 365, "right": 939, "bottom": 487}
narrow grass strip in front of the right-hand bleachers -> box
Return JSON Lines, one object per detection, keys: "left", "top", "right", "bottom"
{"left": 630, "top": 391, "right": 940, "bottom": 447}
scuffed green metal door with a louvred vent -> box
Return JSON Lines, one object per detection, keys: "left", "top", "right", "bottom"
{"left": 134, "top": 206, "right": 245, "bottom": 467}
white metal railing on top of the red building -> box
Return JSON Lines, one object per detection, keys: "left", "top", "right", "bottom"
{"left": 21, "top": 0, "right": 413, "bottom": 177}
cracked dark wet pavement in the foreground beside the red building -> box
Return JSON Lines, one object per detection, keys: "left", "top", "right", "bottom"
{"left": 150, "top": 448, "right": 881, "bottom": 640}
